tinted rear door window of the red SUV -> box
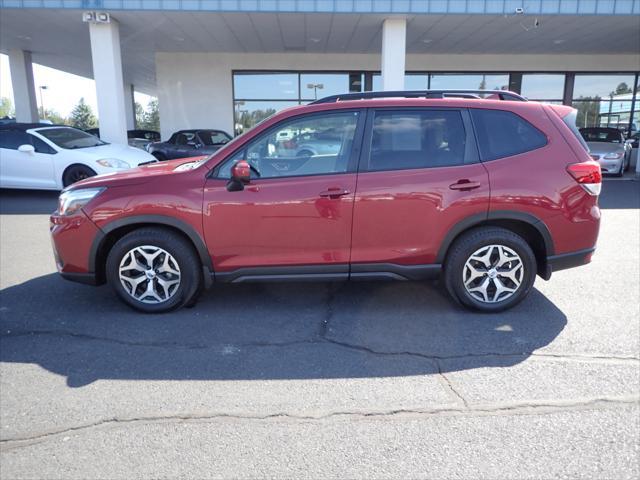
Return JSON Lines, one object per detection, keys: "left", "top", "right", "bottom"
{"left": 366, "top": 110, "right": 467, "bottom": 171}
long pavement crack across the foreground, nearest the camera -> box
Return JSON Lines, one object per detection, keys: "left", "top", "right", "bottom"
{"left": 0, "top": 395, "right": 640, "bottom": 451}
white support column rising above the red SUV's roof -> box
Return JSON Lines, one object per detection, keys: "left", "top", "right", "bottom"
{"left": 382, "top": 18, "right": 407, "bottom": 90}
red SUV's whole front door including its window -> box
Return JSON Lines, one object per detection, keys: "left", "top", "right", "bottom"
{"left": 203, "top": 111, "right": 364, "bottom": 281}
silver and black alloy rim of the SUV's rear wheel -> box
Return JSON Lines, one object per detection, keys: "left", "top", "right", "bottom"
{"left": 462, "top": 245, "right": 524, "bottom": 303}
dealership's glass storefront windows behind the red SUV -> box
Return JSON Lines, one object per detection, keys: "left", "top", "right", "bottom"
{"left": 233, "top": 71, "right": 640, "bottom": 136}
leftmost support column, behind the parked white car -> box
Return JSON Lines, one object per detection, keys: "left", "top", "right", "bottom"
{"left": 9, "top": 50, "right": 40, "bottom": 123}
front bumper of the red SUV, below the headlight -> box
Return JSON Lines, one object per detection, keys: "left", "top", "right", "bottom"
{"left": 49, "top": 210, "right": 102, "bottom": 285}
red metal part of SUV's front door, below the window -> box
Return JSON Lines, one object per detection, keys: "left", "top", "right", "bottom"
{"left": 203, "top": 174, "right": 356, "bottom": 271}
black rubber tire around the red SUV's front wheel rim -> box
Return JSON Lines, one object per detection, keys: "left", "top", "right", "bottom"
{"left": 106, "top": 227, "right": 202, "bottom": 313}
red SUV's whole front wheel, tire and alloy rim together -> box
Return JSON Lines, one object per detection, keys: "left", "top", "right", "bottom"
{"left": 106, "top": 228, "right": 202, "bottom": 313}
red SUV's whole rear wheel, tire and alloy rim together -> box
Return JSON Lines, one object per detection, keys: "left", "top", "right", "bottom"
{"left": 445, "top": 227, "right": 537, "bottom": 312}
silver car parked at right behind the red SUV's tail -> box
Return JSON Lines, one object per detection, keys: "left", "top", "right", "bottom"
{"left": 580, "top": 127, "right": 632, "bottom": 176}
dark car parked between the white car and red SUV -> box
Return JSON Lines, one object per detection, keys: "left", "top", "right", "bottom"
{"left": 147, "top": 129, "right": 231, "bottom": 160}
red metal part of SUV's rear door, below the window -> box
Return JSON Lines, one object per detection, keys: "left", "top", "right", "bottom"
{"left": 351, "top": 163, "right": 489, "bottom": 265}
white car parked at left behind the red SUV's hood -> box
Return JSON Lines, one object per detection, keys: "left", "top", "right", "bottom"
{"left": 0, "top": 123, "right": 156, "bottom": 190}
